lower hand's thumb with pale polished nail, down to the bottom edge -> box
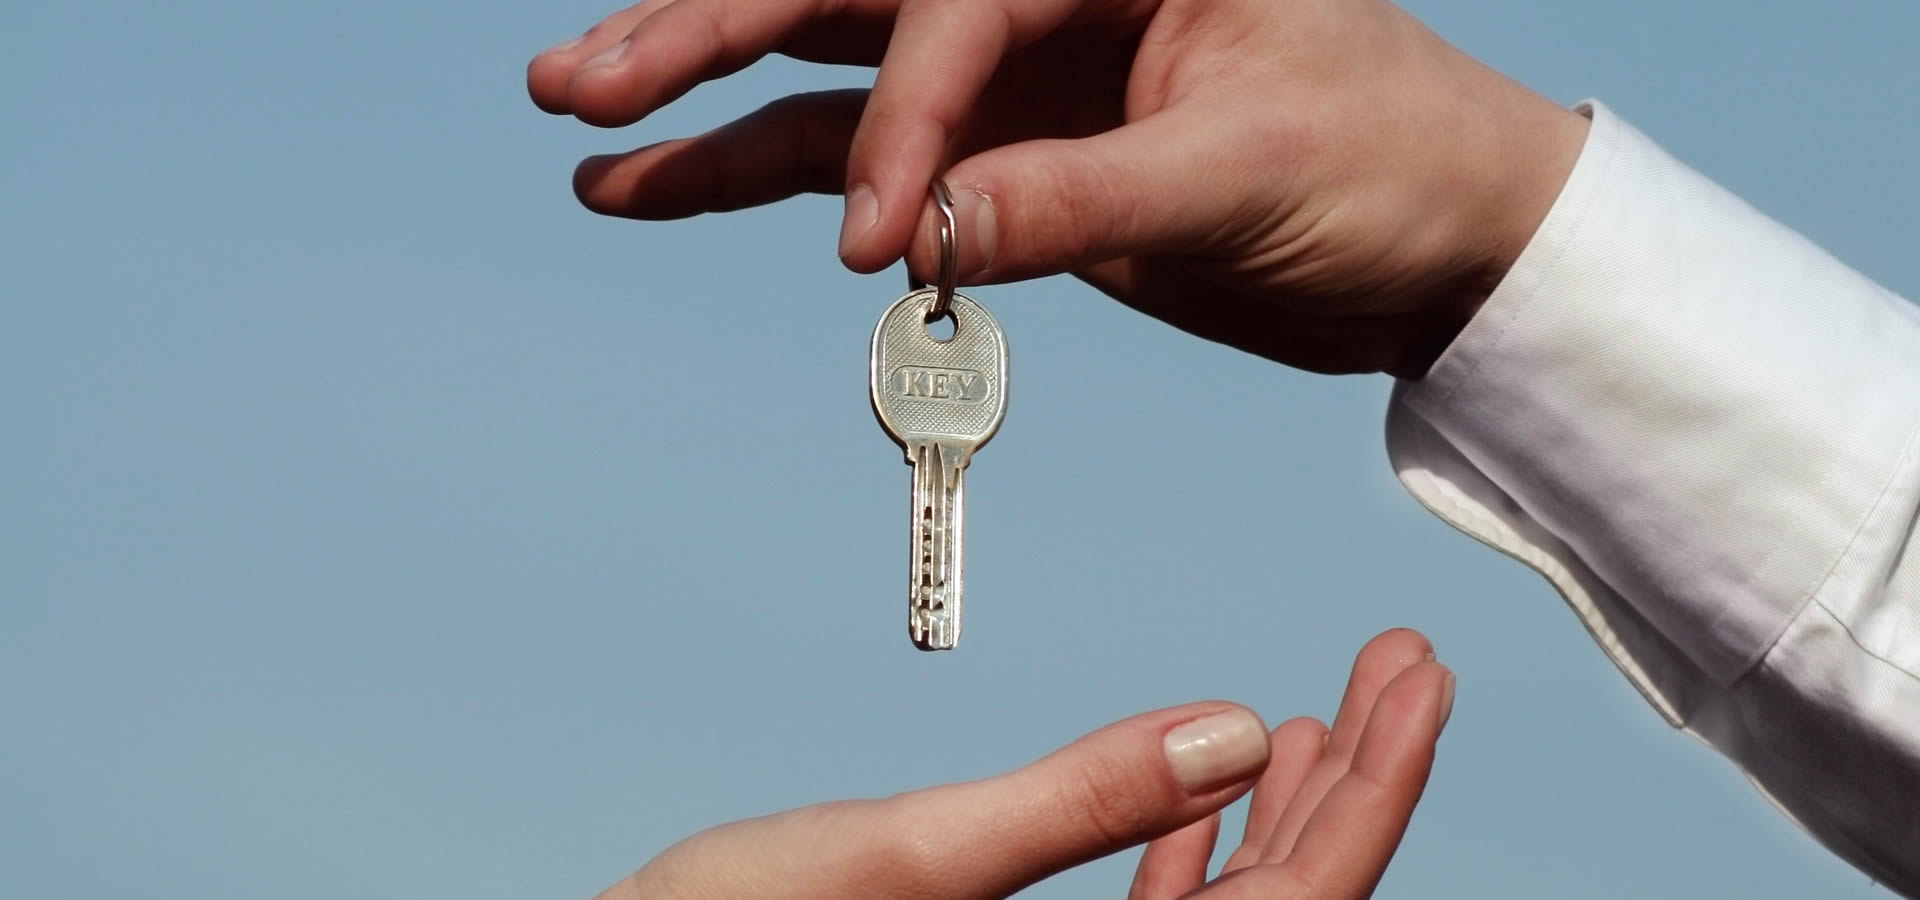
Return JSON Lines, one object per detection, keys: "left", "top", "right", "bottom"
{"left": 599, "top": 702, "right": 1269, "bottom": 900}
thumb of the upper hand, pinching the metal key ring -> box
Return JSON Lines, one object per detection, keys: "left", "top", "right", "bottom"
{"left": 906, "top": 111, "right": 1271, "bottom": 284}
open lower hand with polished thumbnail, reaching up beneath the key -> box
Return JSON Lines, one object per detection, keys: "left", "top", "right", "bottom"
{"left": 583, "top": 631, "right": 1453, "bottom": 900}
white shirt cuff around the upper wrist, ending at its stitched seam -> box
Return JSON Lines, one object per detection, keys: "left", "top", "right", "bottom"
{"left": 1394, "top": 104, "right": 1920, "bottom": 683}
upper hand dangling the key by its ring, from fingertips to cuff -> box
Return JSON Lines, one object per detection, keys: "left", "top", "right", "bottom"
{"left": 528, "top": 0, "right": 1586, "bottom": 378}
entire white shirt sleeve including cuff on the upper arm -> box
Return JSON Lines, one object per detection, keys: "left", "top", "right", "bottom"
{"left": 1386, "top": 104, "right": 1920, "bottom": 896}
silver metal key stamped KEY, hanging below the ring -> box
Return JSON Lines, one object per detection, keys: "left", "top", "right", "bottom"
{"left": 868, "top": 288, "right": 1006, "bottom": 651}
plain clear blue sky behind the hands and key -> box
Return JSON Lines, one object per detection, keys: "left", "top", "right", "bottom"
{"left": 0, "top": 0, "right": 1920, "bottom": 900}
